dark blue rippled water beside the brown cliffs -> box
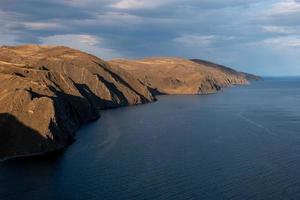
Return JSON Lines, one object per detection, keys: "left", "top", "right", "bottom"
{"left": 0, "top": 78, "right": 300, "bottom": 200}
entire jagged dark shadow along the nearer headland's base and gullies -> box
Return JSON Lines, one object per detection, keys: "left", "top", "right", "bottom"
{"left": 0, "top": 77, "right": 154, "bottom": 160}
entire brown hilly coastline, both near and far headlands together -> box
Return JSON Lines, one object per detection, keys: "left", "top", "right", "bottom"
{"left": 0, "top": 45, "right": 260, "bottom": 160}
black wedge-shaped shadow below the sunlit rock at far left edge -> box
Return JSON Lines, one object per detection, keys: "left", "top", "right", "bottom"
{"left": 0, "top": 113, "right": 63, "bottom": 160}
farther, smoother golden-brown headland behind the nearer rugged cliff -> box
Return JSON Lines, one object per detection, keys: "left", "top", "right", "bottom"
{"left": 110, "top": 57, "right": 255, "bottom": 94}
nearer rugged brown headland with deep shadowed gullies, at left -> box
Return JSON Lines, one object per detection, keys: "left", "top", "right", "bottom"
{"left": 0, "top": 45, "right": 155, "bottom": 159}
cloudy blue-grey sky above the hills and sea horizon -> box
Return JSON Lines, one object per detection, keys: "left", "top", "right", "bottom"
{"left": 0, "top": 0, "right": 300, "bottom": 76}
